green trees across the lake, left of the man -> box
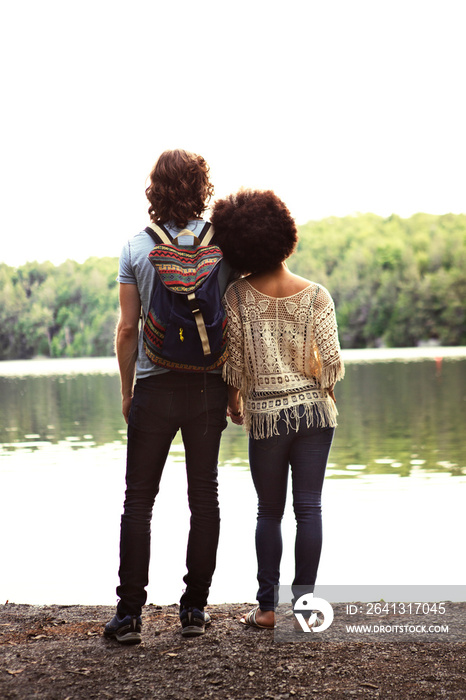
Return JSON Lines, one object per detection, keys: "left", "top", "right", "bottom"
{"left": 0, "top": 258, "right": 118, "bottom": 360}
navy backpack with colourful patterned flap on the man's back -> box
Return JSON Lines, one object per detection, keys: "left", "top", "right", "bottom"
{"left": 143, "top": 223, "right": 227, "bottom": 372}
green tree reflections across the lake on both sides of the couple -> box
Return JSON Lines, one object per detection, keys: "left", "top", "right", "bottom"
{"left": 0, "top": 358, "right": 466, "bottom": 479}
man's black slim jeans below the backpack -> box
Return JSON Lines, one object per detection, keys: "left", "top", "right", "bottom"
{"left": 117, "top": 372, "right": 227, "bottom": 616}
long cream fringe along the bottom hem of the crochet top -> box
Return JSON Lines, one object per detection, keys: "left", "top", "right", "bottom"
{"left": 244, "top": 396, "right": 338, "bottom": 440}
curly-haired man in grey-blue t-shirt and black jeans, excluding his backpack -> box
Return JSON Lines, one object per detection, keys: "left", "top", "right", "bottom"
{"left": 104, "top": 150, "right": 228, "bottom": 644}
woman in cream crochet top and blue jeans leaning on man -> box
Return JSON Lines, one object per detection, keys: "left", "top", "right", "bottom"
{"left": 212, "top": 190, "right": 344, "bottom": 628}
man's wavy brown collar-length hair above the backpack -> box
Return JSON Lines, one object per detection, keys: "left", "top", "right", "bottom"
{"left": 146, "top": 149, "right": 214, "bottom": 228}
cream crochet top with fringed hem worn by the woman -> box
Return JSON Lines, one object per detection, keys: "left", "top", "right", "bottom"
{"left": 223, "top": 278, "right": 345, "bottom": 439}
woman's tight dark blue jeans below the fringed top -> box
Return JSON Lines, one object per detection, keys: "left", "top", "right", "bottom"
{"left": 249, "top": 408, "right": 334, "bottom": 610}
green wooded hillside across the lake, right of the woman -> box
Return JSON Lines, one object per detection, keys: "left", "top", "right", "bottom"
{"left": 290, "top": 214, "right": 466, "bottom": 348}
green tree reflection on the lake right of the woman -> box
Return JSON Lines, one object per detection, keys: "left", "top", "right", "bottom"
{"left": 331, "top": 360, "right": 466, "bottom": 476}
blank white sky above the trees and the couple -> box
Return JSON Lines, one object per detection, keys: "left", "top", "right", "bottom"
{"left": 0, "top": 0, "right": 466, "bottom": 265}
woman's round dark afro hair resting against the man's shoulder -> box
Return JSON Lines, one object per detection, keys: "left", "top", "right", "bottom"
{"left": 211, "top": 189, "right": 298, "bottom": 274}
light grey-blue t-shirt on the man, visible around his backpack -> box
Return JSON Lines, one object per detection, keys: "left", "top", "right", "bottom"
{"left": 117, "top": 220, "right": 231, "bottom": 379}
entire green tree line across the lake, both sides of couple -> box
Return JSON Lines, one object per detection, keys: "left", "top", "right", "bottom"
{"left": 0, "top": 214, "right": 466, "bottom": 360}
